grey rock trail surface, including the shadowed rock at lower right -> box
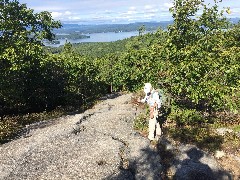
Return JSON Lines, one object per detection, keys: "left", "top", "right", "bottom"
{"left": 0, "top": 94, "right": 236, "bottom": 180}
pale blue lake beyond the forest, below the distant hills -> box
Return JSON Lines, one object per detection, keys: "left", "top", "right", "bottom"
{"left": 48, "top": 31, "right": 139, "bottom": 47}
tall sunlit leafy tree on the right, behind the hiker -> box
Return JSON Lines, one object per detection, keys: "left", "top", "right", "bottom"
{"left": 166, "top": 0, "right": 239, "bottom": 111}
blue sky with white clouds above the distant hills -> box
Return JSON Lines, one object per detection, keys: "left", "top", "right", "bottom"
{"left": 19, "top": 0, "right": 240, "bottom": 24}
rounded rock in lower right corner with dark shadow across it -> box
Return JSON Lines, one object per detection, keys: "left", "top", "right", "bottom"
{"left": 158, "top": 137, "right": 233, "bottom": 180}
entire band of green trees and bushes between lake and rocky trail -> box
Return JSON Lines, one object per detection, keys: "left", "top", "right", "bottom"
{"left": 0, "top": 0, "right": 240, "bottom": 145}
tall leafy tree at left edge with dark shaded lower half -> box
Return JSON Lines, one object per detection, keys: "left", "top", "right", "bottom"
{"left": 0, "top": 0, "right": 61, "bottom": 113}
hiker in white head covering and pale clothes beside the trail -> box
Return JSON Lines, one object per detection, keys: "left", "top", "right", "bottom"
{"left": 141, "top": 83, "right": 162, "bottom": 142}
